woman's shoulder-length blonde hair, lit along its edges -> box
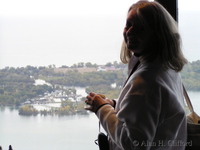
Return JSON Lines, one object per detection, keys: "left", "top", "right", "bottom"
{"left": 120, "top": 1, "right": 187, "bottom": 72}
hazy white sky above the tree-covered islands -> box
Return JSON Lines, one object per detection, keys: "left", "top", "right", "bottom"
{"left": 0, "top": 0, "right": 200, "bottom": 69}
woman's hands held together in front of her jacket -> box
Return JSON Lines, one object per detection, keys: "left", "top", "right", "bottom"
{"left": 85, "top": 92, "right": 114, "bottom": 113}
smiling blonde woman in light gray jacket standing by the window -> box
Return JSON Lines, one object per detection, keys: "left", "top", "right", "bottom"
{"left": 85, "top": 1, "right": 187, "bottom": 150}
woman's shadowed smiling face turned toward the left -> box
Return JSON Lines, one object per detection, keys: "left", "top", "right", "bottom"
{"left": 123, "top": 9, "right": 152, "bottom": 54}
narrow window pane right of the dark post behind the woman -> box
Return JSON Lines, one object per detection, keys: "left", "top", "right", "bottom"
{"left": 178, "top": 0, "right": 200, "bottom": 114}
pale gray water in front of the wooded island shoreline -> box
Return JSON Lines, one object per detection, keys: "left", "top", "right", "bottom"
{"left": 0, "top": 92, "right": 200, "bottom": 150}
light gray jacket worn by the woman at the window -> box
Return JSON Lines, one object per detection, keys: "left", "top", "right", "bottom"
{"left": 96, "top": 57, "right": 187, "bottom": 150}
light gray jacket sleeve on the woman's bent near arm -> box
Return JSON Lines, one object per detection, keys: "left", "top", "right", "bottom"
{"left": 96, "top": 76, "right": 161, "bottom": 150}
